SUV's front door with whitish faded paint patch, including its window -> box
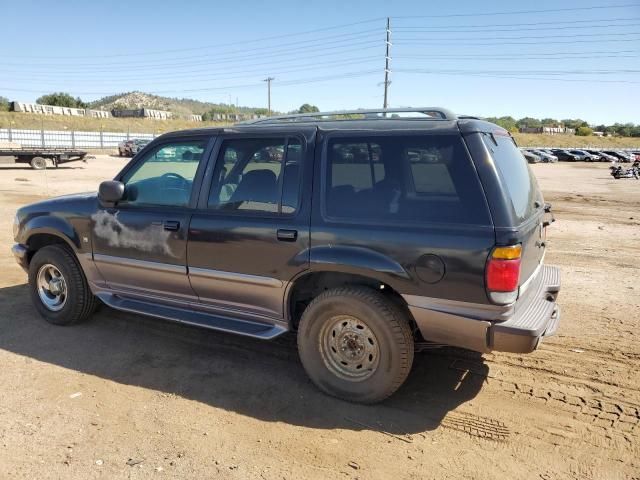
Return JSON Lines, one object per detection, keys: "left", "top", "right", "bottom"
{"left": 92, "top": 137, "right": 209, "bottom": 301}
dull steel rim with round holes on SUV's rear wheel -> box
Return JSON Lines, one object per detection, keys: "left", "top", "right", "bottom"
{"left": 320, "top": 315, "right": 380, "bottom": 381}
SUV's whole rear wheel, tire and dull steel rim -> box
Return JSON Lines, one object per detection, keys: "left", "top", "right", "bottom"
{"left": 298, "top": 287, "right": 414, "bottom": 403}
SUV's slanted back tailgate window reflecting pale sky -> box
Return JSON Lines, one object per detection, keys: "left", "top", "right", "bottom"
{"left": 482, "top": 134, "right": 540, "bottom": 222}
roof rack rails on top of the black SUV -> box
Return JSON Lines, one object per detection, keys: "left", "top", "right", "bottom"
{"left": 240, "top": 107, "right": 458, "bottom": 125}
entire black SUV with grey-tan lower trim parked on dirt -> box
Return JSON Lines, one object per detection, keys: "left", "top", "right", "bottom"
{"left": 13, "top": 108, "right": 560, "bottom": 403}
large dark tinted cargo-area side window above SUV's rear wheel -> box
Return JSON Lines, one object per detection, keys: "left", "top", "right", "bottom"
{"left": 324, "top": 135, "right": 491, "bottom": 225}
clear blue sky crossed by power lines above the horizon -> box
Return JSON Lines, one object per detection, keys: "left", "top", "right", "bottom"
{"left": 0, "top": 0, "right": 640, "bottom": 124}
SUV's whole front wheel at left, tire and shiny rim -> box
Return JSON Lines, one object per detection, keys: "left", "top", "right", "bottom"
{"left": 29, "top": 245, "right": 97, "bottom": 325}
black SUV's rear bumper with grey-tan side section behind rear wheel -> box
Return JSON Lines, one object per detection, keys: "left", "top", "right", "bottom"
{"left": 405, "top": 265, "right": 560, "bottom": 353}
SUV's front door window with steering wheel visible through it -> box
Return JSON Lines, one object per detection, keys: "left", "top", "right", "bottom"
{"left": 122, "top": 140, "right": 207, "bottom": 207}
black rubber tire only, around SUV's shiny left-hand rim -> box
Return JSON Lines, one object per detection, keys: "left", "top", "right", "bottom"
{"left": 29, "top": 245, "right": 98, "bottom": 325}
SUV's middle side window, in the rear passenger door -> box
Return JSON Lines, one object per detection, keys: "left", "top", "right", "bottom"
{"left": 208, "top": 138, "right": 302, "bottom": 213}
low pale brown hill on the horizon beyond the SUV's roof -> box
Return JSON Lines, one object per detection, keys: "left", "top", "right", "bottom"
{"left": 89, "top": 92, "right": 264, "bottom": 115}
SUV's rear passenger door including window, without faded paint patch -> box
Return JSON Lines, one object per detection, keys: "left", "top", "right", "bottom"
{"left": 187, "top": 134, "right": 313, "bottom": 322}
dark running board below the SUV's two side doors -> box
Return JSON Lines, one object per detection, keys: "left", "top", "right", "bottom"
{"left": 96, "top": 293, "right": 287, "bottom": 340}
